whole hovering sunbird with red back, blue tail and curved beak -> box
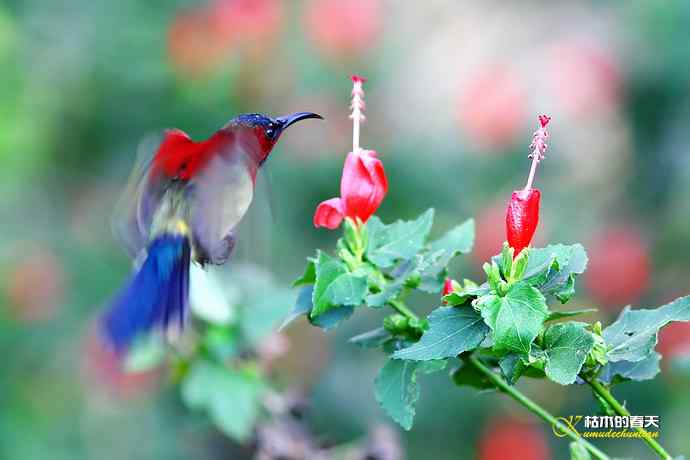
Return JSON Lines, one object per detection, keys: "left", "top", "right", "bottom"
{"left": 102, "top": 112, "right": 322, "bottom": 352}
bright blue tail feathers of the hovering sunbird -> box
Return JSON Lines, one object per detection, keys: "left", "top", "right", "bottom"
{"left": 102, "top": 235, "right": 191, "bottom": 352}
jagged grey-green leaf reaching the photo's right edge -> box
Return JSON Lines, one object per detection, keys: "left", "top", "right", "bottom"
{"left": 603, "top": 296, "right": 690, "bottom": 362}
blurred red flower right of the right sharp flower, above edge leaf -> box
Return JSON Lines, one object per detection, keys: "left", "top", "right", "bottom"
{"left": 585, "top": 225, "right": 650, "bottom": 310}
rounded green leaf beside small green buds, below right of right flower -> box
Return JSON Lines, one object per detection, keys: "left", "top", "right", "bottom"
{"left": 544, "top": 323, "right": 594, "bottom": 385}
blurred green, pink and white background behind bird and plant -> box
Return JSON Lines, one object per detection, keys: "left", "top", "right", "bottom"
{"left": 0, "top": 0, "right": 690, "bottom": 460}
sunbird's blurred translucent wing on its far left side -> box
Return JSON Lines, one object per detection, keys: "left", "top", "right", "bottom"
{"left": 112, "top": 131, "right": 165, "bottom": 258}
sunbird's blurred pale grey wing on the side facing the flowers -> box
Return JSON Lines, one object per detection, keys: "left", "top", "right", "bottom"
{"left": 191, "top": 141, "right": 256, "bottom": 264}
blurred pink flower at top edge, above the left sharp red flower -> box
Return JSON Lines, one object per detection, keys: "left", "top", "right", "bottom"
{"left": 304, "top": 0, "right": 382, "bottom": 58}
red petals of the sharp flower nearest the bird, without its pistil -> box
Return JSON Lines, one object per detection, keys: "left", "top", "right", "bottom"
{"left": 314, "top": 149, "right": 388, "bottom": 230}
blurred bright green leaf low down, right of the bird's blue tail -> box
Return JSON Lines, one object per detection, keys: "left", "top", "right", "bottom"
{"left": 181, "top": 360, "right": 265, "bottom": 441}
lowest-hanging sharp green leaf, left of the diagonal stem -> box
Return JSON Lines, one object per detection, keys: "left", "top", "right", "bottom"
{"left": 374, "top": 359, "right": 446, "bottom": 430}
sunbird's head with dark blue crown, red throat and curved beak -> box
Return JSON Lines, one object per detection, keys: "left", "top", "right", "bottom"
{"left": 226, "top": 112, "right": 323, "bottom": 164}
